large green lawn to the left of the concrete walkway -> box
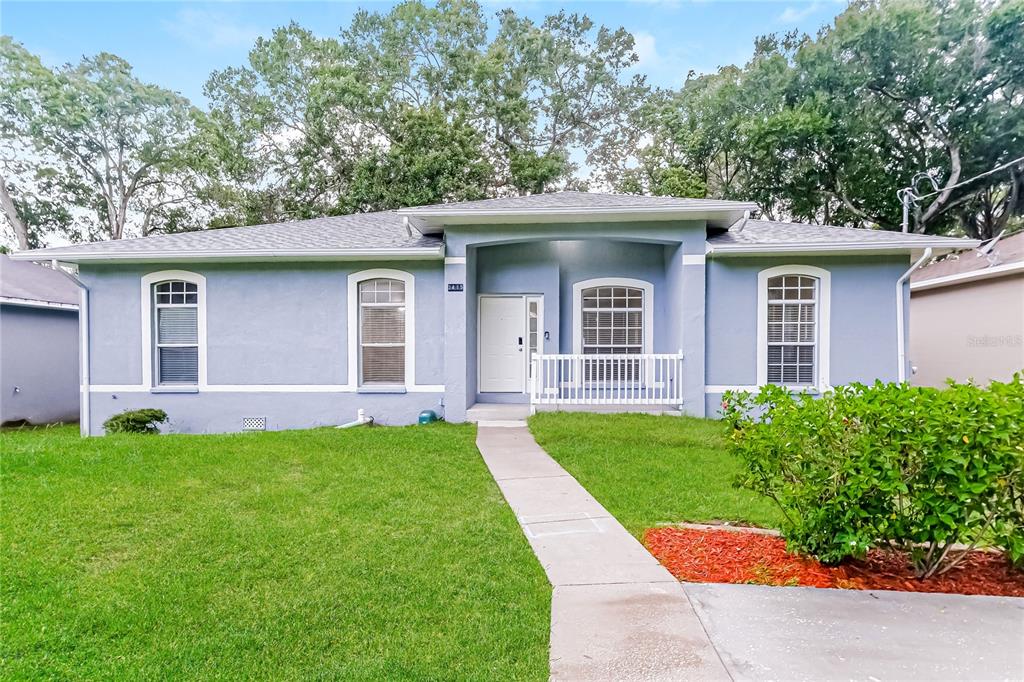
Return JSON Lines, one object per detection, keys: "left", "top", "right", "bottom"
{"left": 0, "top": 424, "right": 550, "bottom": 680}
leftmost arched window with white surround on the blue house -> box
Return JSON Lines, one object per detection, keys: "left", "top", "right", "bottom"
{"left": 142, "top": 270, "right": 206, "bottom": 387}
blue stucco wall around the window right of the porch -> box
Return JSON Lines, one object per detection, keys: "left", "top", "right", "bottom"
{"left": 707, "top": 256, "right": 909, "bottom": 416}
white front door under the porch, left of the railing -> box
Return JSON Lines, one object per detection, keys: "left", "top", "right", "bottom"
{"left": 479, "top": 296, "right": 527, "bottom": 393}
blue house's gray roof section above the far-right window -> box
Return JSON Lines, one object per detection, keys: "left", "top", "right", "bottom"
{"left": 708, "top": 220, "right": 978, "bottom": 254}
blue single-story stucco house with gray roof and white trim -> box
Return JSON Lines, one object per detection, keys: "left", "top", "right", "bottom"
{"left": 9, "top": 191, "right": 976, "bottom": 433}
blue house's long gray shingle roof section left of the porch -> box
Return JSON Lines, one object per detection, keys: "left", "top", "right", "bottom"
{"left": 9, "top": 211, "right": 441, "bottom": 259}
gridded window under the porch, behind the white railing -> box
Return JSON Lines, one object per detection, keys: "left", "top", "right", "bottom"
{"left": 580, "top": 287, "right": 644, "bottom": 380}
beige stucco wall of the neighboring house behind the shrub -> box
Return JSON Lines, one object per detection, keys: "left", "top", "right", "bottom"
{"left": 910, "top": 274, "right": 1024, "bottom": 386}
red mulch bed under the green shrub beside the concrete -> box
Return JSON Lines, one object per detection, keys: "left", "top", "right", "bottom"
{"left": 644, "top": 527, "right": 1024, "bottom": 597}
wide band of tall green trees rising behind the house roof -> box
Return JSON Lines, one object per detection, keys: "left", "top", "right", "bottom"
{"left": 0, "top": 0, "right": 1024, "bottom": 248}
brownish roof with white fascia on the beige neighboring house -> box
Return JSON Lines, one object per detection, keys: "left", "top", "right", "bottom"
{"left": 910, "top": 231, "right": 1024, "bottom": 291}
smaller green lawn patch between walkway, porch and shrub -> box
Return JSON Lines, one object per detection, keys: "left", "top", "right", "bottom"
{"left": 529, "top": 412, "right": 779, "bottom": 538}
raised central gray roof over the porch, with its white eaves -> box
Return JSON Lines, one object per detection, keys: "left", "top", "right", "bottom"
{"left": 398, "top": 191, "right": 758, "bottom": 233}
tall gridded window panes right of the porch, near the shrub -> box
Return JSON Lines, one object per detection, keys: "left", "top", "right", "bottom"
{"left": 767, "top": 274, "right": 819, "bottom": 386}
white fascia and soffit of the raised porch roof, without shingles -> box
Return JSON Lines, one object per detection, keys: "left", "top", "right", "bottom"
{"left": 397, "top": 201, "right": 758, "bottom": 235}
